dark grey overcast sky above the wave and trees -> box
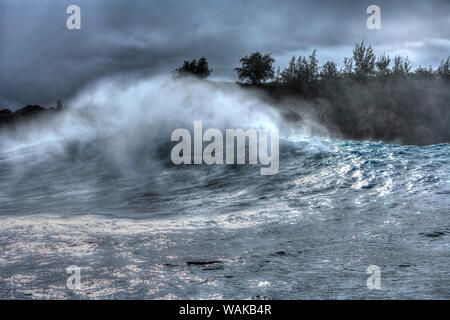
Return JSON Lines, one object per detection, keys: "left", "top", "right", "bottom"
{"left": 0, "top": 0, "right": 450, "bottom": 109}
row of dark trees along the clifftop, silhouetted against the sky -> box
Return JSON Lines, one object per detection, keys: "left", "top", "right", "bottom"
{"left": 173, "top": 42, "right": 450, "bottom": 93}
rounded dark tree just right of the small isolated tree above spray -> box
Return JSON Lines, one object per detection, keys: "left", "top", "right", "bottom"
{"left": 234, "top": 52, "right": 275, "bottom": 85}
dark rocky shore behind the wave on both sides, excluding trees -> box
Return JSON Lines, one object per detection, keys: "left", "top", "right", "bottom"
{"left": 0, "top": 79, "right": 450, "bottom": 145}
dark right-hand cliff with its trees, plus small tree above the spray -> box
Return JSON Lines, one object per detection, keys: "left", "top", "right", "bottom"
{"left": 174, "top": 42, "right": 450, "bottom": 144}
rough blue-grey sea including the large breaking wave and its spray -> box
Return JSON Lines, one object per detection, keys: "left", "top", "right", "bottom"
{"left": 0, "top": 80, "right": 450, "bottom": 299}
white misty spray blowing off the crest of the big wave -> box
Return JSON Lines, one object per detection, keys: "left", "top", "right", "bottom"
{"left": 0, "top": 77, "right": 287, "bottom": 169}
